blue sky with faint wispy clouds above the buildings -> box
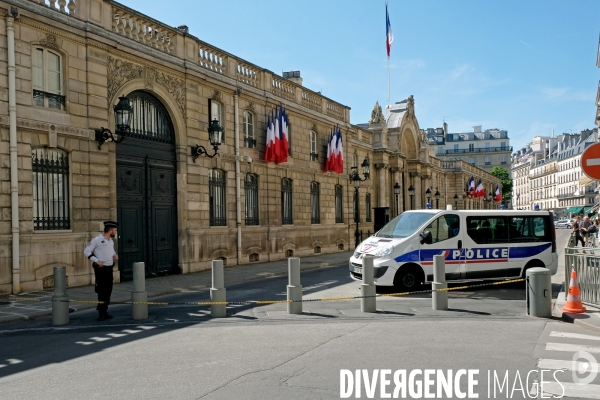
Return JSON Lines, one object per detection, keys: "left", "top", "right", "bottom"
{"left": 122, "top": 0, "right": 600, "bottom": 152}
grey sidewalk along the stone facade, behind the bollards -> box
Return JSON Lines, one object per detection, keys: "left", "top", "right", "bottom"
{"left": 0, "top": 251, "right": 352, "bottom": 324}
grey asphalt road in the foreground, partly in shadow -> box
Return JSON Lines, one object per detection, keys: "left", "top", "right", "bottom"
{"left": 0, "top": 227, "right": 600, "bottom": 399}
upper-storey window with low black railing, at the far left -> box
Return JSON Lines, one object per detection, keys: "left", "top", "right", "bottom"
{"left": 31, "top": 47, "right": 65, "bottom": 110}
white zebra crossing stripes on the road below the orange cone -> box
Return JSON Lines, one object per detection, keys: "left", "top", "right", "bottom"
{"left": 530, "top": 331, "right": 600, "bottom": 399}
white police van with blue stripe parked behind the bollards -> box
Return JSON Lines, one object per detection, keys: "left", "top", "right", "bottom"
{"left": 349, "top": 209, "right": 558, "bottom": 290}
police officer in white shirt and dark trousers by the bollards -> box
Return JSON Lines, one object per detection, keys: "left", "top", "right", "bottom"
{"left": 83, "top": 221, "right": 119, "bottom": 321}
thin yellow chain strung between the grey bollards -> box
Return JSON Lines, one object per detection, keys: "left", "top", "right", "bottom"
{"left": 2, "top": 278, "right": 525, "bottom": 307}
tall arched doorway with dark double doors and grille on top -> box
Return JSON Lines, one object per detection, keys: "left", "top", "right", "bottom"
{"left": 116, "top": 91, "right": 178, "bottom": 280}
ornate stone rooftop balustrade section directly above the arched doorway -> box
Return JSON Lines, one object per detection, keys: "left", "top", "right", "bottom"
{"left": 112, "top": 3, "right": 176, "bottom": 54}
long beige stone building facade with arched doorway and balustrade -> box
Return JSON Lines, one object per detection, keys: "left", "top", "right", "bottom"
{"left": 0, "top": 0, "right": 498, "bottom": 293}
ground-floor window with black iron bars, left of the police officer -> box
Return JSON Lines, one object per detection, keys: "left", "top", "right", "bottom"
{"left": 31, "top": 147, "right": 71, "bottom": 230}
